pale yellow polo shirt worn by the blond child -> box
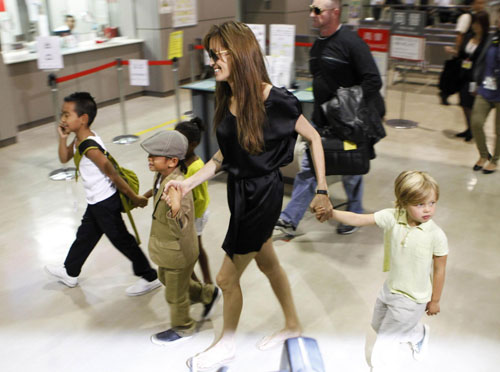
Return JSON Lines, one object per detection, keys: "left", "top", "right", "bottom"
{"left": 375, "top": 208, "right": 448, "bottom": 303}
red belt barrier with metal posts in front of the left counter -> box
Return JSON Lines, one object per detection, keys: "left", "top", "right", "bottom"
{"left": 48, "top": 58, "right": 181, "bottom": 181}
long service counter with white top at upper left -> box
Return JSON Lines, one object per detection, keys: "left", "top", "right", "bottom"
{"left": 0, "top": 38, "right": 143, "bottom": 146}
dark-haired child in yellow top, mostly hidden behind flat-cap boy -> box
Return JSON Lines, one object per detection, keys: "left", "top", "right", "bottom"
{"left": 175, "top": 117, "right": 213, "bottom": 284}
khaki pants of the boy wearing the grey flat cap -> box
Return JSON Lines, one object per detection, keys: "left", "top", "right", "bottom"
{"left": 158, "top": 263, "right": 215, "bottom": 335}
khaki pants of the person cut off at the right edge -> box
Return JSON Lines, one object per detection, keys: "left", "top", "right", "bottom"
{"left": 471, "top": 94, "right": 500, "bottom": 164}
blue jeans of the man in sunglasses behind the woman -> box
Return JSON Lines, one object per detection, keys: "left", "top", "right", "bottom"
{"left": 280, "top": 153, "right": 363, "bottom": 227}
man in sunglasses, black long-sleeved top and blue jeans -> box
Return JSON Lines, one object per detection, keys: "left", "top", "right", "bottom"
{"left": 275, "top": 0, "right": 385, "bottom": 235}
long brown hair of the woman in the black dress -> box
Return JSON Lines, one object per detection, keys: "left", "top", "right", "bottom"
{"left": 203, "top": 21, "right": 271, "bottom": 154}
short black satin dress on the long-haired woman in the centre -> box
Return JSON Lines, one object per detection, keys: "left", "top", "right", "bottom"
{"left": 217, "top": 86, "right": 302, "bottom": 259}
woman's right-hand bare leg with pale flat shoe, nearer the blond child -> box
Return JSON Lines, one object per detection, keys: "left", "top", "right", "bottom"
{"left": 255, "top": 238, "right": 302, "bottom": 350}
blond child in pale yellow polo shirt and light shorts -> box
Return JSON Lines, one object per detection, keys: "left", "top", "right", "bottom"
{"left": 316, "top": 171, "right": 448, "bottom": 370}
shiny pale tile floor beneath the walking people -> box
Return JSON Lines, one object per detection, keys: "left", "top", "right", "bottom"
{"left": 0, "top": 86, "right": 500, "bottom": 372}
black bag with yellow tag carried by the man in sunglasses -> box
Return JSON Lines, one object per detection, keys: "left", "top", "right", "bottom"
{"left": 306, "top": 137, "right": 370, "bottom": 176}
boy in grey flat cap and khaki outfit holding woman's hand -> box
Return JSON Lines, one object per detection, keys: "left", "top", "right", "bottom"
{"left": 141, "top": 131, "right": 221, "bottom": 345}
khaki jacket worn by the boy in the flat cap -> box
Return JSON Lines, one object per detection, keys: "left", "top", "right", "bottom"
{"left": 148, "top": 168, "right": 199, "bottom": 269}
